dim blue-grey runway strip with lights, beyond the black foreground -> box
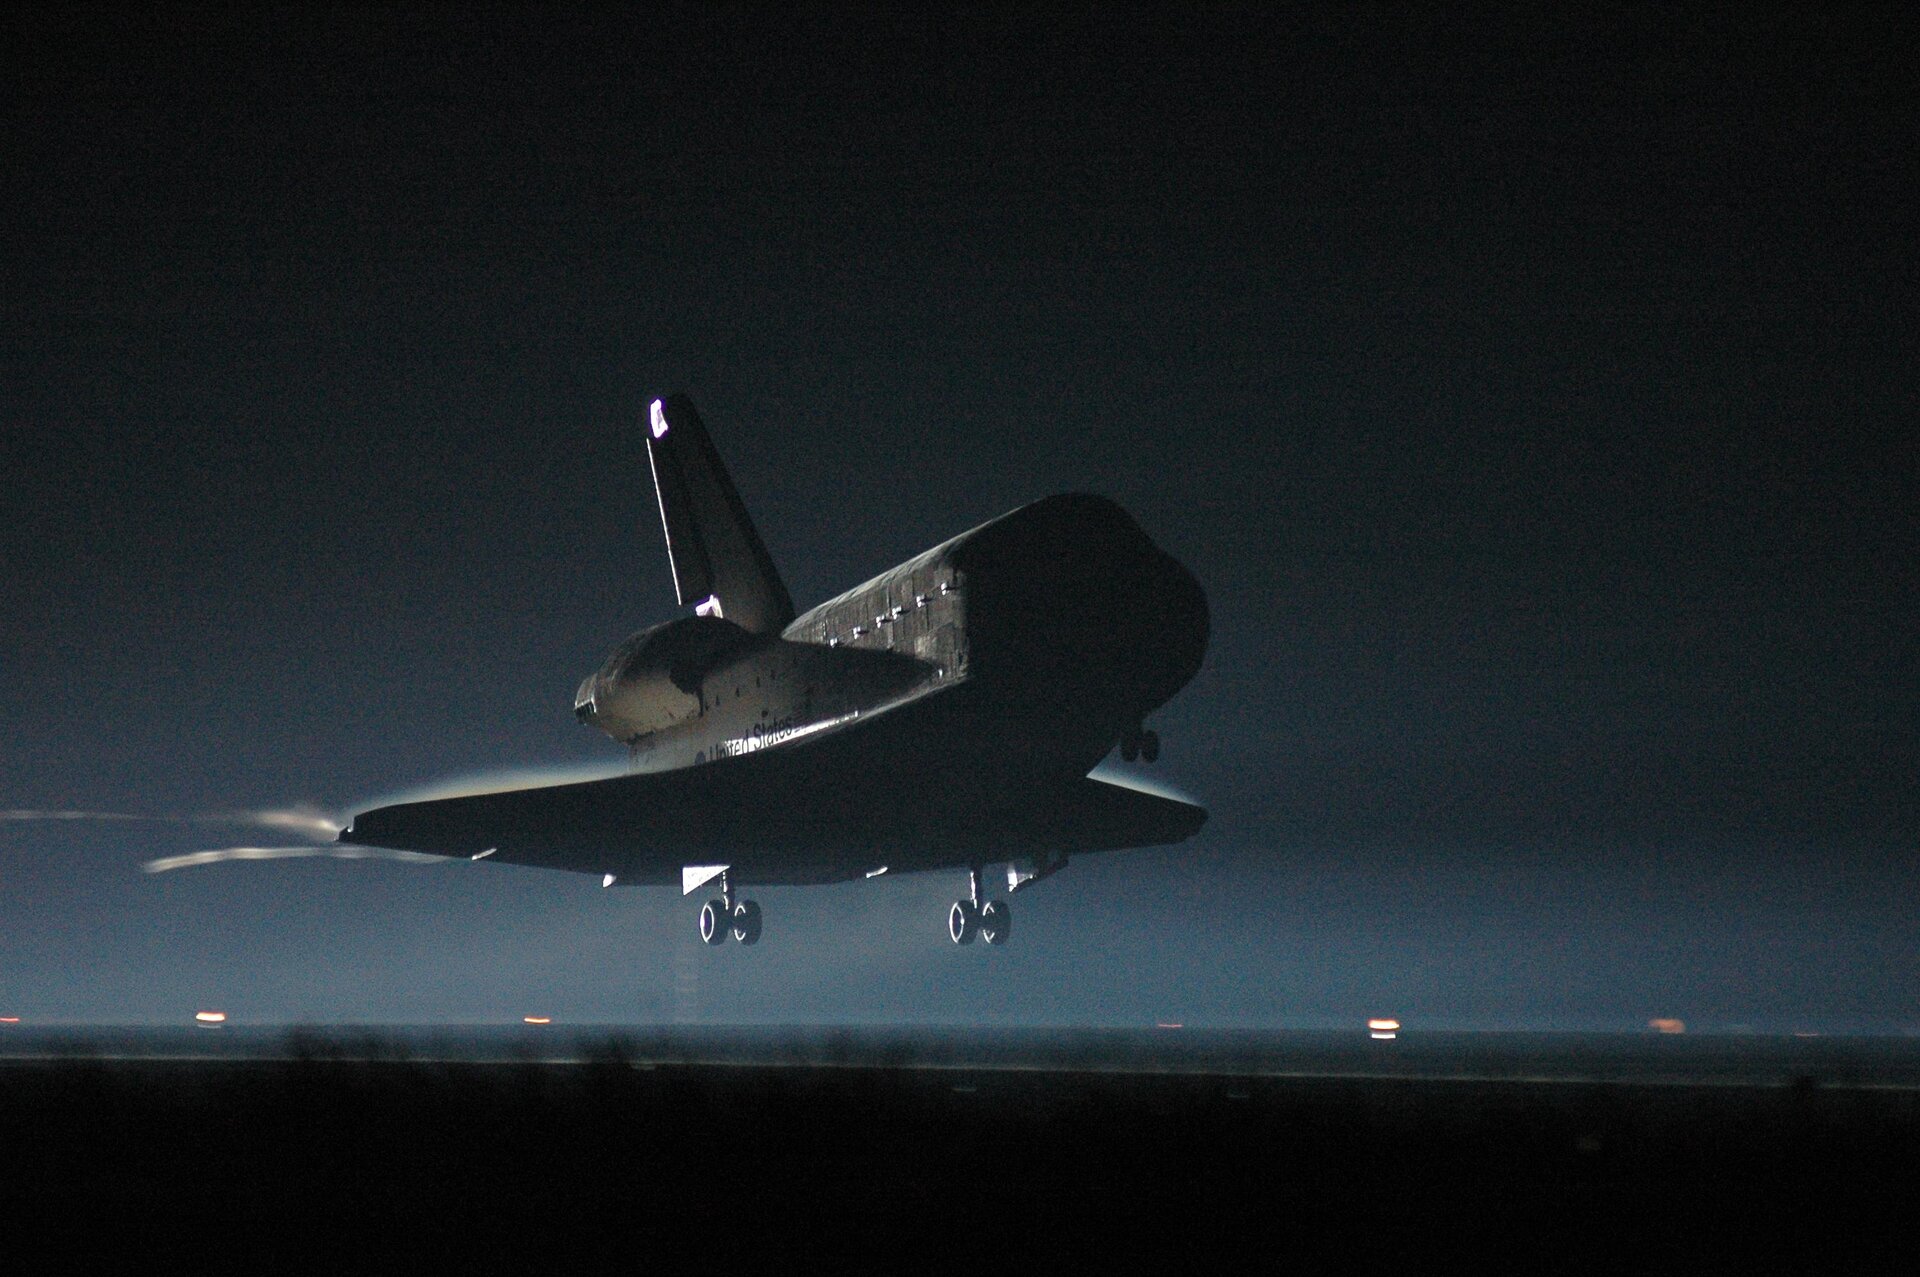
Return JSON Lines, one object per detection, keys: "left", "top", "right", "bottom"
{"left": 0, "top": 1020, "right": 1920, "bottom": 1091}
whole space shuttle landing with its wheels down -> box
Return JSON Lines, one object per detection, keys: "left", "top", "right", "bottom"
{"left": 340, "top": 396, "right": 1210, "bottom": 945}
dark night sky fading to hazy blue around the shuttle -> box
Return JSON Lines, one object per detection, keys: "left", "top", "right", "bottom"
{"left": 0, "top": 6, "right": 1920, "bottom": 1031}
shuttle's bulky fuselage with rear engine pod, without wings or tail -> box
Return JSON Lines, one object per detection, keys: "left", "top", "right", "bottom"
{"left": 574, "top": 494, "right": 1208, "bottom": 776}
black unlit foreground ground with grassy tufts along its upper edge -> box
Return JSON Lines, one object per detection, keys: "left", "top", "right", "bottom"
{"left": 0, "top": 1037, "right": 1920, "bottom": 1273}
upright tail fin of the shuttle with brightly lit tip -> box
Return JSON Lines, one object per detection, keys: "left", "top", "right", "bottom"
{"left": 647, "top": 396, "right": 793, "bottom": 634}
